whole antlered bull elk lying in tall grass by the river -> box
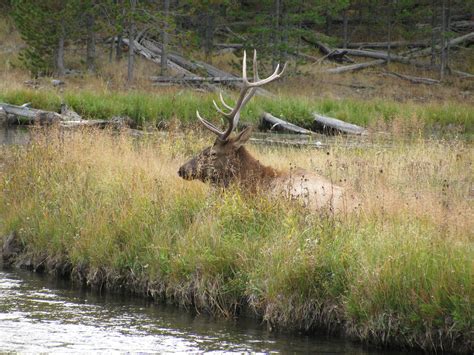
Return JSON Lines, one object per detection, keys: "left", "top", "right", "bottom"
{"left": 178, "top": 51, "right": 356, "bottom": 212}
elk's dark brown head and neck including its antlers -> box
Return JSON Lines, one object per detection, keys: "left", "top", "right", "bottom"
{"left": 178, "top": 51, "right": 286, "bottom": 186}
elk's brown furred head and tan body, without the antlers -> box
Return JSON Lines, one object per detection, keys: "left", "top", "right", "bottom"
{"left": 178, "top": 128, "right": 356, "bottom": 212}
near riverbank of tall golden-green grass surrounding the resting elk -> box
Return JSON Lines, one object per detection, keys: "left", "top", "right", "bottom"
{"left": 0, "top": 129, "right": 474, "bottom": 352}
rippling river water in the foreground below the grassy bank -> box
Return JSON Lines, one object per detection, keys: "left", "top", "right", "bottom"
{"left": 0, "top": 270, "right": 408, "bottom": 354}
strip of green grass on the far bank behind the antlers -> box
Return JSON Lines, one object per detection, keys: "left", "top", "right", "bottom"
{"left": 0, "top": 89, "right": 474, "bottom": 134}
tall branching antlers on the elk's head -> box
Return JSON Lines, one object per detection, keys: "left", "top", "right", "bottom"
{"left": 196, "top": 50, "right": 287, "bottom": 141}
